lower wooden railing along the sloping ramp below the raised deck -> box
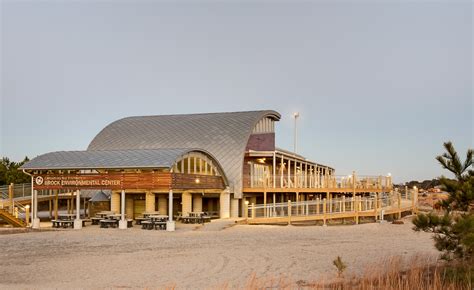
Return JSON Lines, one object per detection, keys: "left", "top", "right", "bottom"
{"left": 246, "top": 190, "right": 416, "bottom": 219}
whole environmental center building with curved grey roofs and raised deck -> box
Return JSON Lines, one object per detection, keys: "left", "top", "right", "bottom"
{"left": 22, "top": 110, "right": 391, "bottom": 230}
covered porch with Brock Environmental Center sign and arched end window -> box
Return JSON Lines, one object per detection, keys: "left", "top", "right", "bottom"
{"left": 19, "top": 149, "right": 230, "bottom": 231}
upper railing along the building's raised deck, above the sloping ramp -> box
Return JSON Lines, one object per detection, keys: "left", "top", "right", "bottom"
{"left": 244, "top": 173, "right": 392, "bottom": 191}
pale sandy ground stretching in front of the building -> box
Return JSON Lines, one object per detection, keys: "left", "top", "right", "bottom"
{"left": 0, "top": 220, "right": 438, "bottom": 289}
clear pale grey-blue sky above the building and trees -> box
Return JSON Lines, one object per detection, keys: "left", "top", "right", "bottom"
{"left": 0, "top": 0, "right": 474, "bottom": 182}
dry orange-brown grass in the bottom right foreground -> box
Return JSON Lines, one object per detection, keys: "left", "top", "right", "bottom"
{"left": 228, "top": 256, "right": 474, "bottom": 290}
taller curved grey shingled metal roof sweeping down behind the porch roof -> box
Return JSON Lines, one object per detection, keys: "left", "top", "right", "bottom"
{"left": 87, "top": 110, "right": 281, "bottom": 197}
